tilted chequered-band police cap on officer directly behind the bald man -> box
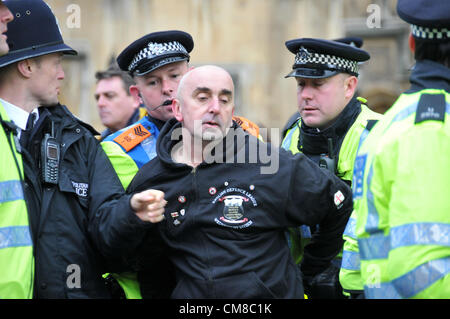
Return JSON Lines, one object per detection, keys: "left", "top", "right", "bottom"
{"left": 117, "top": 30, "right": 194, "bottom": 75}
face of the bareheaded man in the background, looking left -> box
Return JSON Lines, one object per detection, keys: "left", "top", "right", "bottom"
{"left": 94, "top": 76, "right": 139, "bottom": 132}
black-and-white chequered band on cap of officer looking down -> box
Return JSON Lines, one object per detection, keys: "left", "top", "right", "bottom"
{"left": 294, "top": 47, "right": 359, "bottom": 74}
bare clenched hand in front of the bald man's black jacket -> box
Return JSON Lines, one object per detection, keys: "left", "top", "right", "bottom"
{"left": 130, "top": 189, "right": 167, "bottom": 223}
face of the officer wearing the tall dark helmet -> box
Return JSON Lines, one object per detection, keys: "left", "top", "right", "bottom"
{"left": 30, "top": 53, "right": 64, "bottom": 106}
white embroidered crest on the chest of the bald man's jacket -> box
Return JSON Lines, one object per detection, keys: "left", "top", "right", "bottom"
{"left": 212, "top": 188, "right": 258, "bottom": 229}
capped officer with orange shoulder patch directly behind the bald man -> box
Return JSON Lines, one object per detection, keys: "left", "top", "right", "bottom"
{"left": 102, "top": 30, "right": 194, "bottom": 188}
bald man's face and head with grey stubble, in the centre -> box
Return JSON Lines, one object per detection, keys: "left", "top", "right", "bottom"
{"left": 174, "top": 66, "right": 234, "bottom": 141}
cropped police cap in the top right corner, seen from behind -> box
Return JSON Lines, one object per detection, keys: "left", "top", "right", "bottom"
{"left": 397, "top": 0, "right": 450, "bottom": 42}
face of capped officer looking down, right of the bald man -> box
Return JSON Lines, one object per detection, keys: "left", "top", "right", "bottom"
{"left": 296, "top": 74, "right": 356, "bottom": 129}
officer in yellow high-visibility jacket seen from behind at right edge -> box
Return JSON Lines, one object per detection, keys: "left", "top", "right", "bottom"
{"left": 353, "top": 0, "right": 450, "bottom": 299}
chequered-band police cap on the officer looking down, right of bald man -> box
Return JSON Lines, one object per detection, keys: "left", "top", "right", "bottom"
{"left": 285, "top": 38, "right": 370, "bottom": 78}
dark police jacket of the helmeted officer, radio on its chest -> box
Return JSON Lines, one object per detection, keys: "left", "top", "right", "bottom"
{"left": 22, "top": 105, "right": 152, "bottom": 299}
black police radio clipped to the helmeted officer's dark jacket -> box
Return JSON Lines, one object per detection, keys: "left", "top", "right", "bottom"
{"left": 41, "top": 122, "right": 60, "bottom": 184}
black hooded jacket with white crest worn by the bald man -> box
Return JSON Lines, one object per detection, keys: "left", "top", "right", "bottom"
{"left": 127, "top": 119, "right": 352, "bottom": 298}
